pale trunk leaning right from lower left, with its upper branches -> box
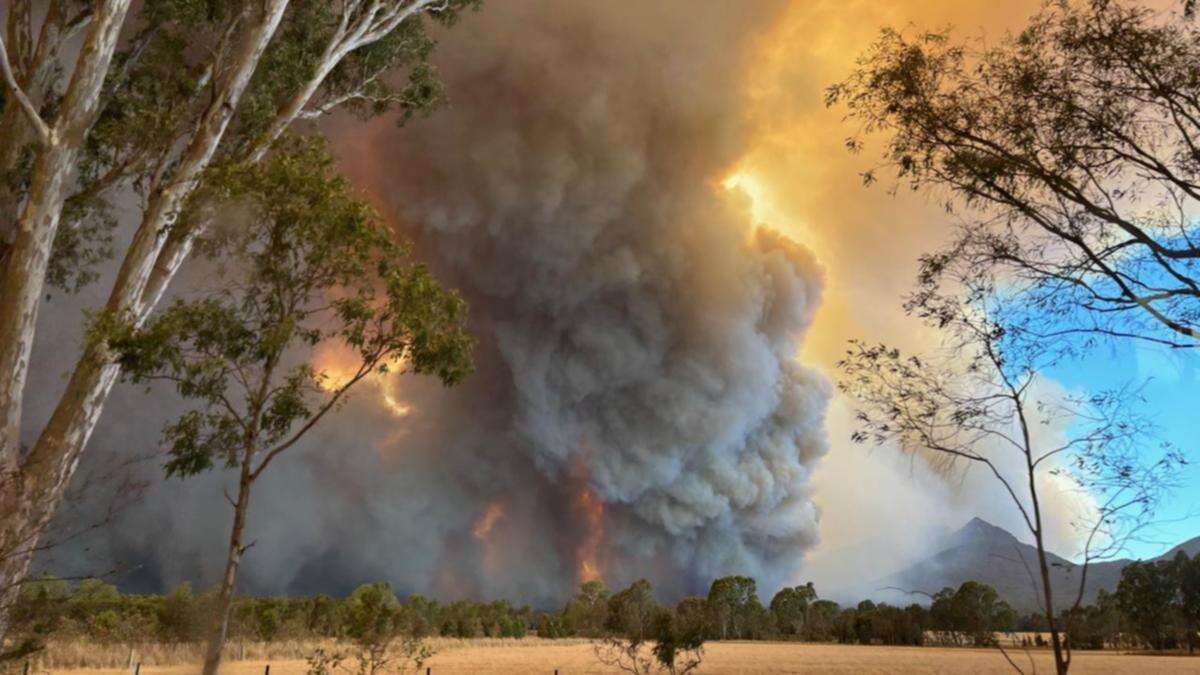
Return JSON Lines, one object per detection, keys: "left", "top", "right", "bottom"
{"left": 0, "top": 0, "right": 446, "bottom": 640}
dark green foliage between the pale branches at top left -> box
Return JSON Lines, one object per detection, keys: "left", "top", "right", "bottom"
{"left": 35, "top": 0, "right": 479, "bottom": 292}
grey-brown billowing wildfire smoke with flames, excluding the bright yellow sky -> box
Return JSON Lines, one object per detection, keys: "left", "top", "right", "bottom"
{"left": 43, "top": 0, "right": 829, "bottom": 603}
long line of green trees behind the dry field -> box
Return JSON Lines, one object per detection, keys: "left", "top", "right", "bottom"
{"left": 13, "top": 551, "right": 1200, "bottom": 652}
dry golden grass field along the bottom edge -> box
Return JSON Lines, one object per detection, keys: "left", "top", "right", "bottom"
{"left": 43, "top": 639, "right": 1200, "bottom": 675}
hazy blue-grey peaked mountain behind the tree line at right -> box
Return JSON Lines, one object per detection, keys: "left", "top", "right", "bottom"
{"left": 875, "top": 518, "right": 1200, "bottom": 614}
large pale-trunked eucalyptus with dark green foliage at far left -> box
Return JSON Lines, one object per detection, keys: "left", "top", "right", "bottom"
{"left": 0, "top": 0, "right": 478, "bottom": 639}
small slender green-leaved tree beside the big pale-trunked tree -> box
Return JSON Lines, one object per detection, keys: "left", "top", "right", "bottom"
{"left": 110, "top": 139, "right": 472, "bottom": 673}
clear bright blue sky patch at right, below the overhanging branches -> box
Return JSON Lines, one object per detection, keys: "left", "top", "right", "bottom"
{"left": 1043, "top": 340, "right": 1200, "bottom": 557}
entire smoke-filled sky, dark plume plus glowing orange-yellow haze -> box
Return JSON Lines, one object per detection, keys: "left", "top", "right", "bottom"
{"left": 34, "top": 0, "right": 1196, "bottom": 604}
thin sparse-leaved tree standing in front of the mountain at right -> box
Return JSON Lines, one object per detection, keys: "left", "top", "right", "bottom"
{"left": 838, "top": 282, "right": 1186, "bottom": 675}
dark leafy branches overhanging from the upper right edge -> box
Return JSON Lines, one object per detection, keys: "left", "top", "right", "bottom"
{"left": 827, "top": 0, "right": 1200, "bottom": 350}
